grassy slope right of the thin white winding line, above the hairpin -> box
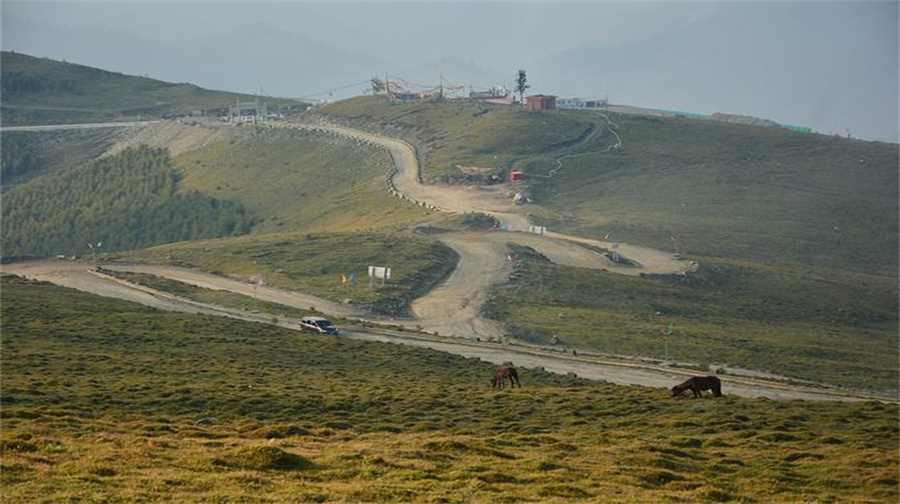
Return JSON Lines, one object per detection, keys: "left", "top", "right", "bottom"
{"left": 524, "top": 112, "right": 900, "bottom": 277}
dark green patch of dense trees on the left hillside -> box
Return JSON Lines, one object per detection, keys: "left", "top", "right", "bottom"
{"left": 0, "top": 146, "right": 255, "bottom": 257}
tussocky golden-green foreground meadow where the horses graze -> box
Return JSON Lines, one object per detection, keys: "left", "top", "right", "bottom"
{"left": 0, "top": 277, "right": 900, "bottom": 503}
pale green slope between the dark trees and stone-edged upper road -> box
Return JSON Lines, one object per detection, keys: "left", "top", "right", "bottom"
{"left": 175, "top": 126, "right": 432, "bottom": 234}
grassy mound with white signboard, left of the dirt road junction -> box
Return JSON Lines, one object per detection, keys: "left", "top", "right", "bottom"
{"left": 116, "top": 233, "right": 457, "bottom": 315}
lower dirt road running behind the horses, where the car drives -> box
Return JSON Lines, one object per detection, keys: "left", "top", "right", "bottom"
{"left": 2, "top": 260, "right": 884, "bottom": 401}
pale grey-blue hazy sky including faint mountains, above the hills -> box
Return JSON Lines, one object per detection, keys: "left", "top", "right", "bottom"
{"left": 0, "top": 1, "right": 900, "bottom": 142}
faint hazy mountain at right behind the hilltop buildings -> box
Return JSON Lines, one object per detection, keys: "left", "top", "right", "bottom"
{"left": 529, "top": 3, "right": 898, "bottom": 142}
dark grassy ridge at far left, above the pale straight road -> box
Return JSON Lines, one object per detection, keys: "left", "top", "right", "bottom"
{"left": 0, "top": 51, "right": 302, "bottom": 126}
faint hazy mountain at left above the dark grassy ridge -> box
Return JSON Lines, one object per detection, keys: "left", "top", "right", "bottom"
{"left": 3, "top": 15, "right": 398, "bottom": 100}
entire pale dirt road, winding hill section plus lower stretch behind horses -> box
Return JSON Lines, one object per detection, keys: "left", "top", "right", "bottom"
{"left": 2, "top": 124, "right": 883, "bottom": 400}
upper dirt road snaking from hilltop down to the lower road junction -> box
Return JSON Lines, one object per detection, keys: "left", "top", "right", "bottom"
{"left": 288, "top": 120, "right": 696, "bottom": 339}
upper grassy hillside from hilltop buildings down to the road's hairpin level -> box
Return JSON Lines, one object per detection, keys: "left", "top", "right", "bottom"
{"left": 317, "top": 97, "right": 900, "bottom": 273}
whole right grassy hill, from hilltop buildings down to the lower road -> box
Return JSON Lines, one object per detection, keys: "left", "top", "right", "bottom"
{"left": 319, "top": 98, "right": 900, "bottom": 390}
